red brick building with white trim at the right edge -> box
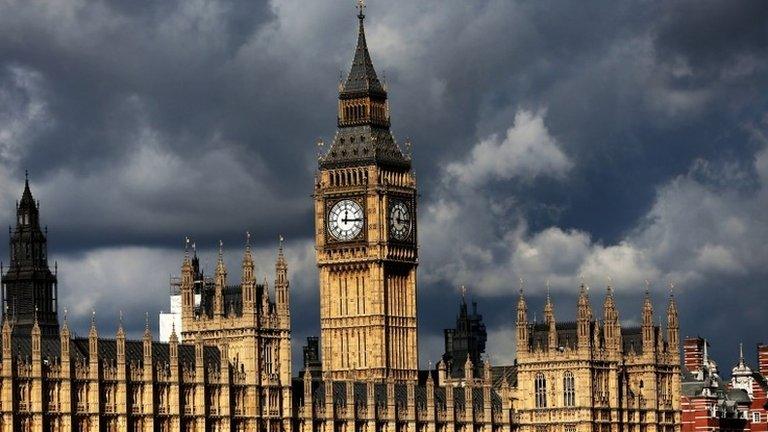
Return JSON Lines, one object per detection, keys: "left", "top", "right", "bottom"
{"left": 681, "top": 337, "right": 768, "bottom": 432}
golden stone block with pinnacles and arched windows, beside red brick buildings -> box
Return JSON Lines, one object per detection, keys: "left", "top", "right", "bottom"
{"left": 513, "top": 285, "right": 680, "bottom": 432}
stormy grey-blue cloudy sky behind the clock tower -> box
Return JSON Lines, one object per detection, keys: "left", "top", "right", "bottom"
{"left": 0, "top": 0, "right": 768, "bottom": 372}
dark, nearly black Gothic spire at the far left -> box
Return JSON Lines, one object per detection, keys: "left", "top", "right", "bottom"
{"left": 0, "top": 177, "right": 59, "bottom": 337}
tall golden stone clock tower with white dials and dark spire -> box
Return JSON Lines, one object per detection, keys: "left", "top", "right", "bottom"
{"left": 314, "top": 2, "right": 418, "bottom": 380}
